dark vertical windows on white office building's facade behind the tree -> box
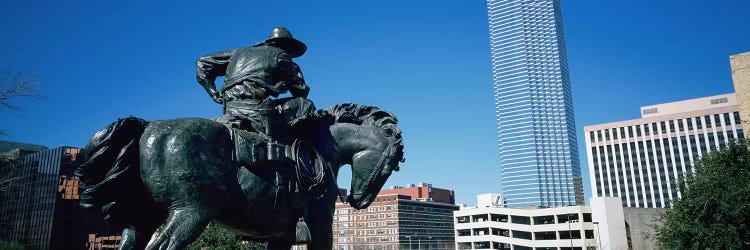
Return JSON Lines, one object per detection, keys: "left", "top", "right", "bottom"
{"left": 591, "top": 129, "right": 743, "bottom": 207}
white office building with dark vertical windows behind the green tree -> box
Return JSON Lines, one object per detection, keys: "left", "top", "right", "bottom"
{"left": 584, "top": 93, "right": 743, "bottom": 208}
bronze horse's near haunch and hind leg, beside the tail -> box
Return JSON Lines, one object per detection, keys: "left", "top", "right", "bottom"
{"left": 140, "top": 119, "right": 237, "bottom": 250}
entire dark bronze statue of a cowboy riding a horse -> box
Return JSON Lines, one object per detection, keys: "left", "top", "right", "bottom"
{"left": 76, "top": 28, "right": 403, "bottom": 250}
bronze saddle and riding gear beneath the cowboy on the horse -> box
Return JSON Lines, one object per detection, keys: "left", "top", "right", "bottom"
{"left": 216, "top": 98, "right": 333, "bottom": 197}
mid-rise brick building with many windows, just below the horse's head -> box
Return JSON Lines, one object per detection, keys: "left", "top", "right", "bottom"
{"left": 333, "top": 183, "right": 459, "bottom": 250}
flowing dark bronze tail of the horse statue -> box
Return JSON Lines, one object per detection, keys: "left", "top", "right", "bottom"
{"left": 75, "top": 116, "right": 148, "bottom": 224}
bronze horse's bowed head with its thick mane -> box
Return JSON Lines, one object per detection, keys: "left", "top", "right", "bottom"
{"left": 326, "top": 103, "right": 404, "bottom": 209}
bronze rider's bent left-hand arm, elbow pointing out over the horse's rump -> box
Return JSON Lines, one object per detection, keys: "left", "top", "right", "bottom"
{"left": 195, "top": 49, "right": 236, "bottom": 103}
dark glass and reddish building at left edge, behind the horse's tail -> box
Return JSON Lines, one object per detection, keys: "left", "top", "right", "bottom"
{"left": 0, "top": 144, "right": 120, "bottom": 250}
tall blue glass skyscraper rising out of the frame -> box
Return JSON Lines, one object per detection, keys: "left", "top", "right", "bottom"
{"left": 487, "top": 0, "right": 583, "bottom": 207}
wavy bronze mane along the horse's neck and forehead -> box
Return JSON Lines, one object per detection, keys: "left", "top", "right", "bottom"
{"left": 325, "top": 103, "right": 404, "bottom": 162}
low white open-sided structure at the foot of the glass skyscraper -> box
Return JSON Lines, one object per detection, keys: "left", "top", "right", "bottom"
{"left": 453, "top": 195, "right": 628, "bottom": 250}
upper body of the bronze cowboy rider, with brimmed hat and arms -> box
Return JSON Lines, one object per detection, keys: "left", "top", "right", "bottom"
{"left": 196, "top": 27, "right": 315, "bottom": 143}
